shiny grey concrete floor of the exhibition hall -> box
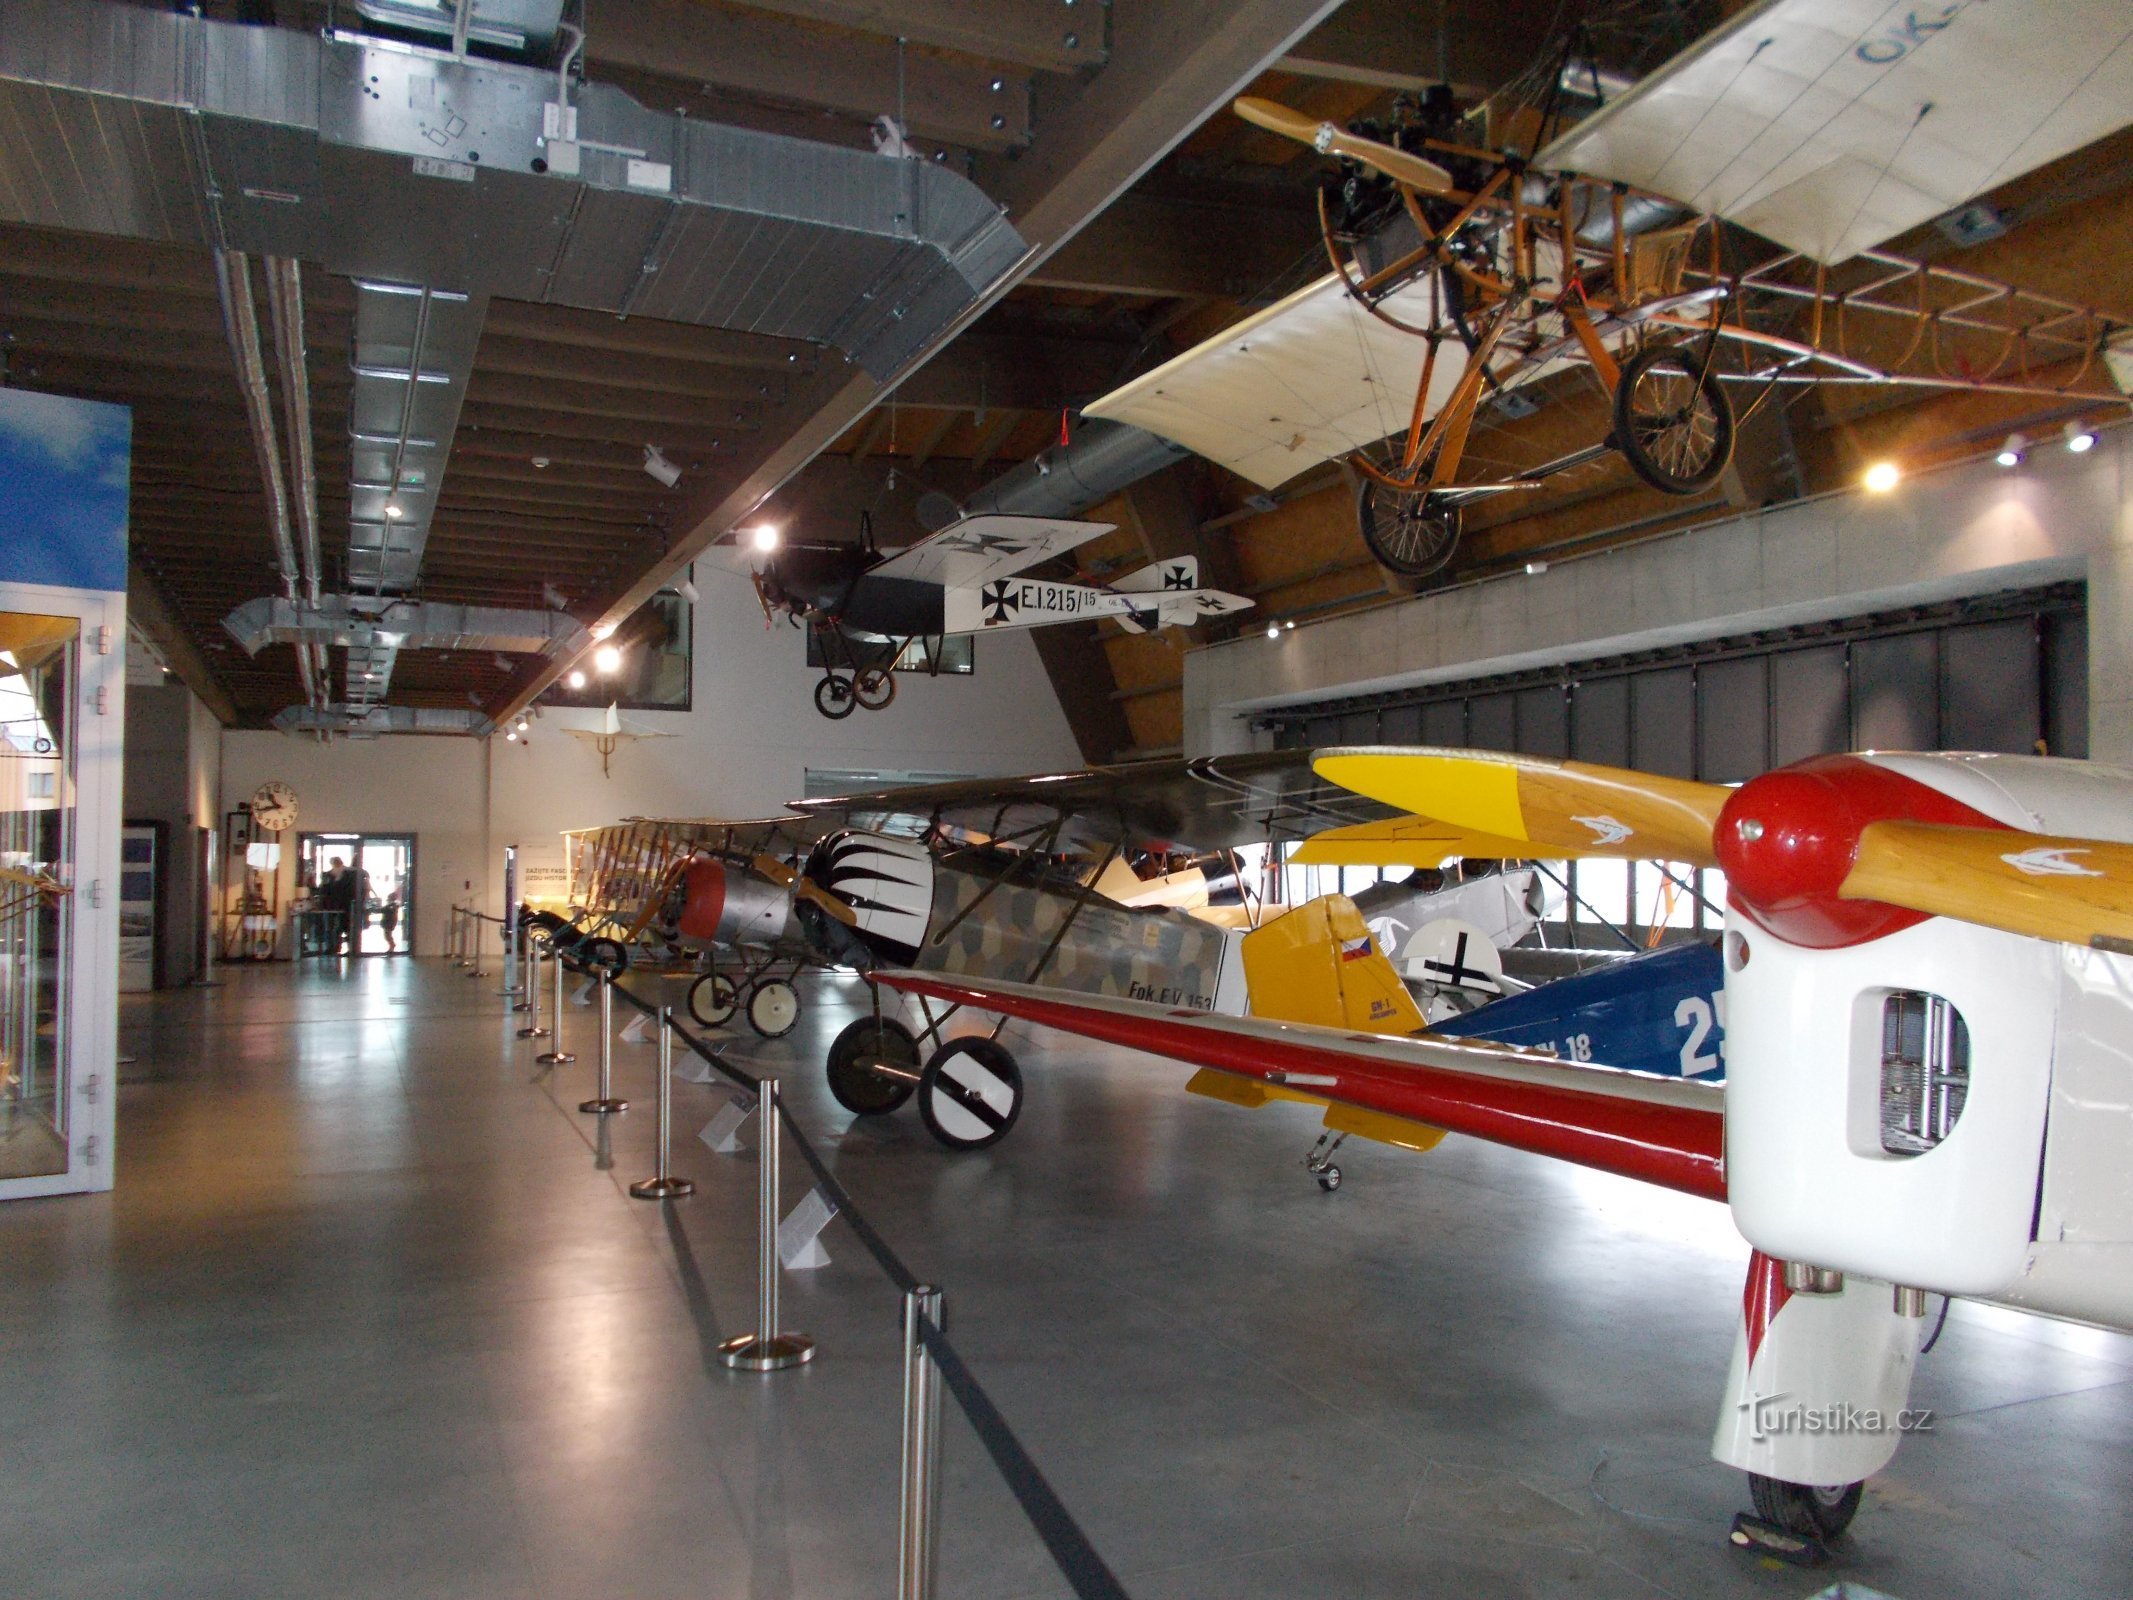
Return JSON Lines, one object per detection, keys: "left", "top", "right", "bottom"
{"left": 0, "top": 960, "right": 2133, "bottom": 1600}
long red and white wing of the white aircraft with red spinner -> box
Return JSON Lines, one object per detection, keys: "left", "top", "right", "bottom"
{"left": 875, "top": 973, "right": 1726, "bottom": 1201}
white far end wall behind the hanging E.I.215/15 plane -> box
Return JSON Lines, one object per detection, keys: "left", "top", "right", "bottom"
{"left": 222, "top": 561, "right": 1081, "bottom": 954}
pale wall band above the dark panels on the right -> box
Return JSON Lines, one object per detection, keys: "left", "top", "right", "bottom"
{"left": 1184, "top": 429, "right": 2133, "bottom": 762}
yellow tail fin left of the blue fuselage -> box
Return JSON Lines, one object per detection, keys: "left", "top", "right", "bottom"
{"left": 1244, "top": 894, "right": 1423, "bottom": 1035}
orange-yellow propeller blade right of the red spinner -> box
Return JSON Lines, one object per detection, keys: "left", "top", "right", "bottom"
{"left": 1837, "top": 821, "right": 2133, "bottom": 954}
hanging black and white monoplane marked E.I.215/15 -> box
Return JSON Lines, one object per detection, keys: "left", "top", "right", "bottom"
{"left": 755, "top": 514, "right": 1252, "bottom": 719}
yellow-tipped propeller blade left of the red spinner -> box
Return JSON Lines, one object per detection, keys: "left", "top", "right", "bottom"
{"left": 1312, "top": 749, "right": 1732, "bottom": 866}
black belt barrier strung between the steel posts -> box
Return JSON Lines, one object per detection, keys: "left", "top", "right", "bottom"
{"left": 584, "top": 975, "right": 1130, "bottom": 1600}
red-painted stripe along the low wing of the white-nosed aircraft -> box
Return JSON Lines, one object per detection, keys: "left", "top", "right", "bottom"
{"left": 881, "top": 973, "right": 1726, "bottom": 1201}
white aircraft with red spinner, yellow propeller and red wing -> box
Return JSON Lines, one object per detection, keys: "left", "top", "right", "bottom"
{"left": 879, "top": 749, "right": 2133, "bottom": 1540}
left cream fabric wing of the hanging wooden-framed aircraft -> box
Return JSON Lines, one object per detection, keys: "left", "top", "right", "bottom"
{"left": 1081, "top": 275, "right": 1465, "bottom": 489}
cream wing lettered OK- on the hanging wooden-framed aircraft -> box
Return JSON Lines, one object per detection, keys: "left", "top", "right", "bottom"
{"left": 1538, "top": 0, "right": 2133, "bottom": 262}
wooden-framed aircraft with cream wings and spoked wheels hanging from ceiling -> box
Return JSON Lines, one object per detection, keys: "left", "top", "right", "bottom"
{"left": 1086, "top": 0, "right": 2133, "bottom": 576}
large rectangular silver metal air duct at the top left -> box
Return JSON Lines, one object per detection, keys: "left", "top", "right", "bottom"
{"left": 0, "top": 0, "right": 1026, "bottom": 378}
